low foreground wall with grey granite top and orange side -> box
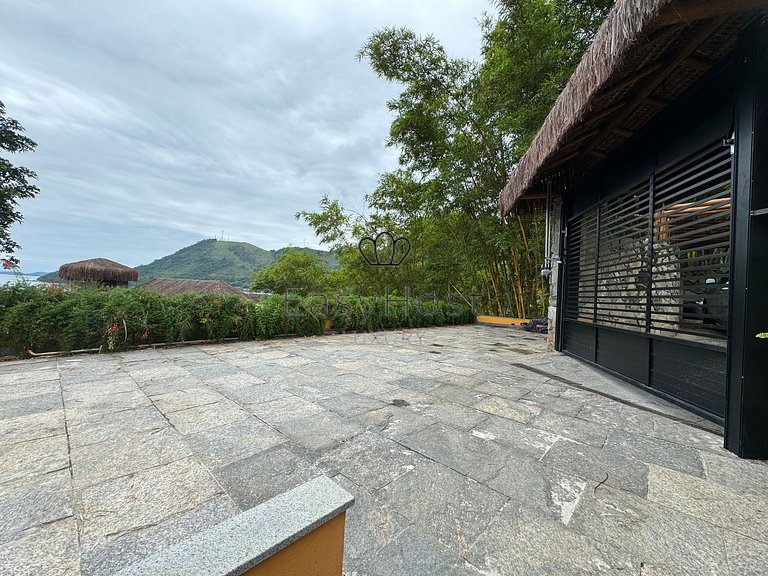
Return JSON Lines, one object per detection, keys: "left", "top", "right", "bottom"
{"left": 117, "top": 476, "right": 354, "bottom": 576}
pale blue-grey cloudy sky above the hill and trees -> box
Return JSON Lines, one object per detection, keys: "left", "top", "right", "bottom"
{"left": 0, "top": 0, "right": 491, "bottom": 272}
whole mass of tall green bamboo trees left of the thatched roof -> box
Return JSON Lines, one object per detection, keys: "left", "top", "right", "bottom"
{"left": 298, "top": 0, "right": 612, "bottom": 317}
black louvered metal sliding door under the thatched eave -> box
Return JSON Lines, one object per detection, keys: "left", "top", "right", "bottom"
{"left": 563, "top": 139, "right": 732, "bottom": 419}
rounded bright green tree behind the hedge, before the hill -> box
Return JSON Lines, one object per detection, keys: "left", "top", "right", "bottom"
{"left": 251, "top": 248, "right": 334, "bottom": 294}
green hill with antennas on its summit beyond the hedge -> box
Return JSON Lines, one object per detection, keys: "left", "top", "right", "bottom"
{"left": 40, "top": 238, "right": 338, "bottom": 288}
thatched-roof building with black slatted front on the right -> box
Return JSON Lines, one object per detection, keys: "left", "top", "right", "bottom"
{"left": 499, "top": 0, "right": 768, "bottom": 458}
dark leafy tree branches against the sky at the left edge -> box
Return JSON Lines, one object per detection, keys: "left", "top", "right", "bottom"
{"left": 0, "top": 101, "right": 39, "bottom": 262}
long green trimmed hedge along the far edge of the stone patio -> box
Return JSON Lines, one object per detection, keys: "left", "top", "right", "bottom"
{"left": 0, "top": 284, "right": 474, "bottom": 354}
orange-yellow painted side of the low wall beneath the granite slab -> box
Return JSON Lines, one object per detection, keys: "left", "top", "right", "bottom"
{"left": 244, "top": 513, "right": 346, "bottom": 576}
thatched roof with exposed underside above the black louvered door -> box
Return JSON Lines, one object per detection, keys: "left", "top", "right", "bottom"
{"left": 499, "top": 0, "right": 768, "bottom": 215}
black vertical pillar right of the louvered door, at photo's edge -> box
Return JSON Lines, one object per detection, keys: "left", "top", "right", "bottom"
{"left": 725, "top": 23, "right": 768, "bottom": 460}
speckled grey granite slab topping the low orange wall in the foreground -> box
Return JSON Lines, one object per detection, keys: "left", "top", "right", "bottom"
{"left": 116, "top": 476, "right": 355, "bottom": 576}
